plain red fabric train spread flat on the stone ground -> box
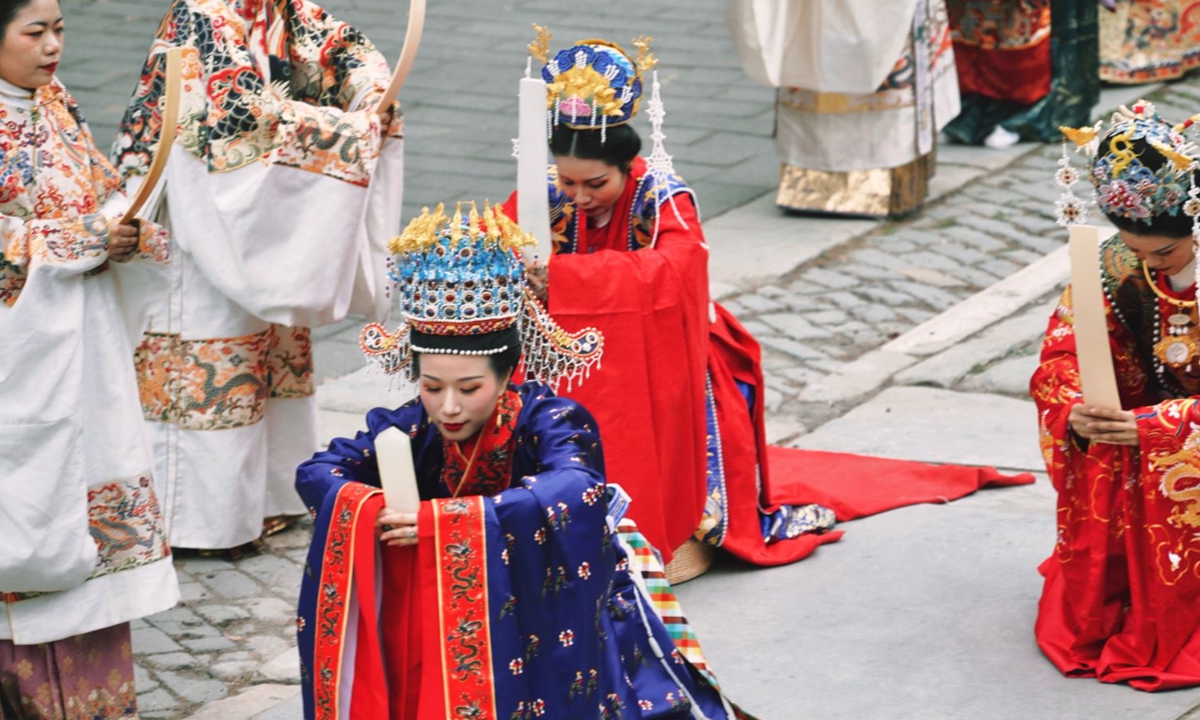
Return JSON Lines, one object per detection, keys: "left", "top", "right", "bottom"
{"left": 766, "top": 446, "right": 1033, "bottom": 522}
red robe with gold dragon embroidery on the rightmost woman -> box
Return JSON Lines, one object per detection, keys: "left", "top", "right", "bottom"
{"left": 1031, "top": 239, "right": 1200, "bottom": 690}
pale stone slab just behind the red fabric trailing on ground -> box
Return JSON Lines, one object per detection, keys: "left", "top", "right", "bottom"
{"left": 797, "top": 386, "right": 1045, "bottom": 470}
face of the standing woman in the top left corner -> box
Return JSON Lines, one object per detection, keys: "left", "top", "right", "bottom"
{"left": 0, "top": 0, "right": 64, "bottom": 90}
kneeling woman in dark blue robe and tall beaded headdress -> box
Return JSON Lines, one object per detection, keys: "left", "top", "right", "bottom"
{"left": 296, "top": 201, "right": 744, "bottom": 720}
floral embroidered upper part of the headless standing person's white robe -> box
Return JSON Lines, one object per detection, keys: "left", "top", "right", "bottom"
{"left": 114, "top": 0, "right": 402, "bottom": 186}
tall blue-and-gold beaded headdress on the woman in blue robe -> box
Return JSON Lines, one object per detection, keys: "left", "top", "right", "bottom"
{"left": 360, "top": 203, "right": 604, "bottom": 388}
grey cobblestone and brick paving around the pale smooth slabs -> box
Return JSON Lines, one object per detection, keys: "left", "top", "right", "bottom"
{"left": 51, "top": 0, "right": 1200, "bottom": 719}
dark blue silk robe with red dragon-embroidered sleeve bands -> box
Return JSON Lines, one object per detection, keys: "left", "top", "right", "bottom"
{"left": 296, "top": 383, "right": 736, "bottom": 720}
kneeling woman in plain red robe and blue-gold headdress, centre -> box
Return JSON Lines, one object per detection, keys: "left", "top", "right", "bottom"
{"left": 505, "top": 41, "right": 839, "bottom": 564}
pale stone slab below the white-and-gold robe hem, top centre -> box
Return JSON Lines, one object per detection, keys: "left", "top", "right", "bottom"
{"left": 704, "top": 191, "right": 880, "bottom": 290}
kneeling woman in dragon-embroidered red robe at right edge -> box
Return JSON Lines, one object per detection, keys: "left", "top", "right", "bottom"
{"left": 1030, "top": 103, "right": 1200, "bottom": 690}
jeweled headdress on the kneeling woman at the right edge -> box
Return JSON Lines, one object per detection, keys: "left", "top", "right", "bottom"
{"left": 1055, "top": 101, "right": 1200, "bottom": 229}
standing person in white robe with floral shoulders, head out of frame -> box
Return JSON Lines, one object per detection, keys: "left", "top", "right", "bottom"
{"left": 114, "top": 0, "right": 402, "bottom": 550}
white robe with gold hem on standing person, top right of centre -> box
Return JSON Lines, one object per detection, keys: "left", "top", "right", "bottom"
{"left": 728, "top": 0, "right": 959, "bottom": 217}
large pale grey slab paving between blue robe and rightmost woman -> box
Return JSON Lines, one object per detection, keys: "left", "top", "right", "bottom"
{"left": 677, "top": 478, "right": 1200, "bottom": 720}
